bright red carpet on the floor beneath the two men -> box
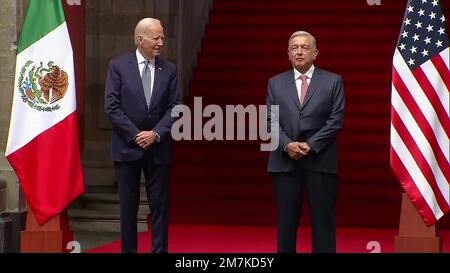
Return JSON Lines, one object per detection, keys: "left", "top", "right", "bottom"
{"left": 86, "top": 225, "right": 450, "bottom": 253}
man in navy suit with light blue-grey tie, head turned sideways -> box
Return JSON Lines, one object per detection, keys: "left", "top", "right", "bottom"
{"left": 105, "top": 18, "right": 180, "bottom": 253}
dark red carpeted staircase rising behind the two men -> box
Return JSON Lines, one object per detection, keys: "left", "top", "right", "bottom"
{"left": 170, "top": 0, "right": 450, "bottom": 226}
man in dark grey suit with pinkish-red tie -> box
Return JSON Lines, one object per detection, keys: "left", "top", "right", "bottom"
{"left": 267, "top": 31, "right": 345, "bottom": 253}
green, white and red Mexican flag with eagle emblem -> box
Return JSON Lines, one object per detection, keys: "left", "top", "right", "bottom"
{"left": 5, "top": 0, "right": 84, "bottom": 225}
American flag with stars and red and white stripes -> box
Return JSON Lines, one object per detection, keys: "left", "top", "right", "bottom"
{"left": 390, "top": 0, "right": 450, "bottom": 225}
